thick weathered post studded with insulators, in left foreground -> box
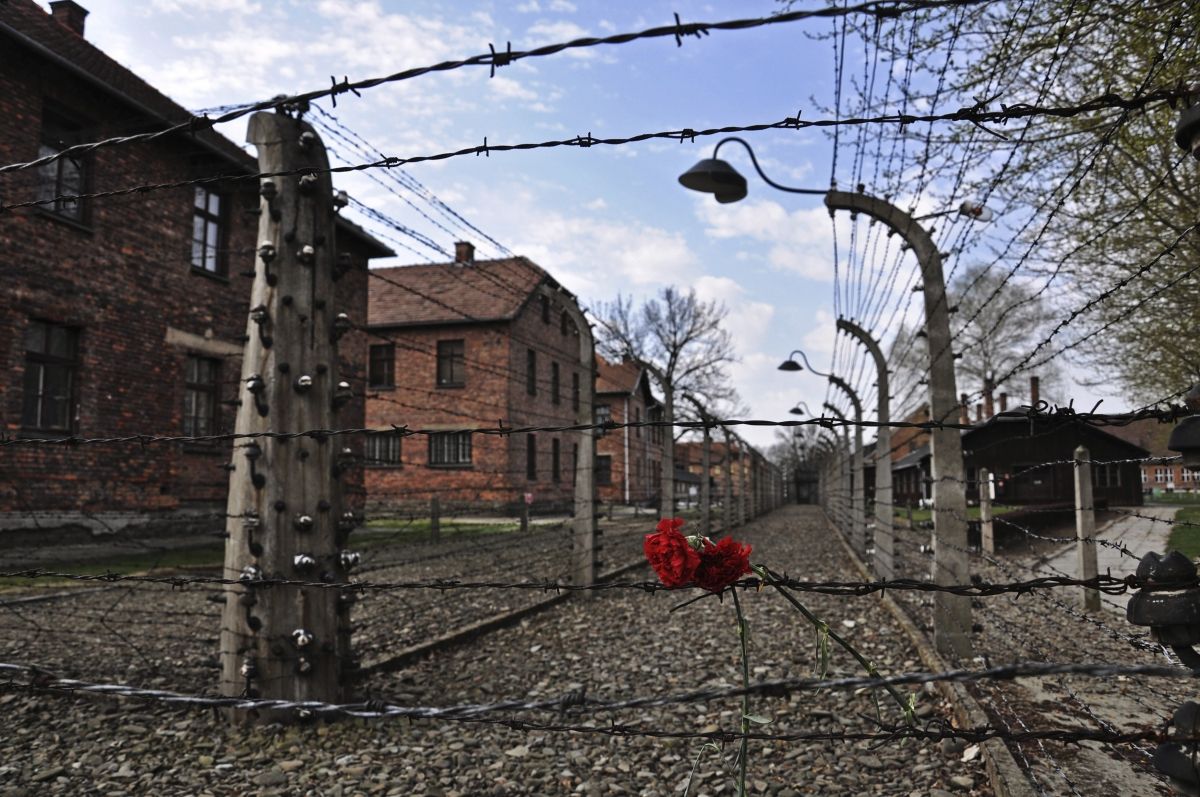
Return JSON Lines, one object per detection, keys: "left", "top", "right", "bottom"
{"left": 220, "top": 112, "right": 352, "bottom": 721}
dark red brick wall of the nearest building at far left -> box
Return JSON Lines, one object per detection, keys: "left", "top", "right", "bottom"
{"left": 0, "top": 39, "right": 366, "bottom": 528}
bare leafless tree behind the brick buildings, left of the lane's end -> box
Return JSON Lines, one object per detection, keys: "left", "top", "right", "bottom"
{"left": 593, "top": 286, "right": 734, "bottom": 517}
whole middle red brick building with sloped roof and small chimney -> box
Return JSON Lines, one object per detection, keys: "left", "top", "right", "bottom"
{"left": 366, "top": 242, "right": 593, "bottom": 514}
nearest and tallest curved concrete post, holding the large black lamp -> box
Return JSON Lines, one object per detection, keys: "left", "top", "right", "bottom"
{"left": 826, "top": 191, "right": 971, "bottom": 658}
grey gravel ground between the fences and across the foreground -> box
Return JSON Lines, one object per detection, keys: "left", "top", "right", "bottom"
{"left": 0, "top": 507, "right": 993, "bottom": 797}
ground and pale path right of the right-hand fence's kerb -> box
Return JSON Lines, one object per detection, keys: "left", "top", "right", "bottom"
{"left": 900, "top": 507, "right": 1180, "bottom": 797}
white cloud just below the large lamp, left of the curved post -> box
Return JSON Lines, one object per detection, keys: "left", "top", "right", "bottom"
{"left": 697, "top": 197, "right": 833, "bottom": 282}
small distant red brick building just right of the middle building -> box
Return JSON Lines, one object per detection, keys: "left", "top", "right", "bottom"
{"left": 595, "top": 355, "right": 667, "bottom": 507}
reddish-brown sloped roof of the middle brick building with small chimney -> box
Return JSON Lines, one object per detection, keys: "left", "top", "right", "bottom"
{"left": 367, "top": 257, "right": 557, "bottom": 328}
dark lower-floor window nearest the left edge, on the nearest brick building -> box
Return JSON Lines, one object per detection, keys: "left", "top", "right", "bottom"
{"left": 20, "top": 320, "right": 79, "bottom": 431}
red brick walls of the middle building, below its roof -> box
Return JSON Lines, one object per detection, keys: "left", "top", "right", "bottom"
{"left": 366, "top": 283, "right": 590, "bottom": 515}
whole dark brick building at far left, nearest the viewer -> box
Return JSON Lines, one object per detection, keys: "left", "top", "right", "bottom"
{"left": 0, "top": 0, "right": 391, "bottom": 531}
